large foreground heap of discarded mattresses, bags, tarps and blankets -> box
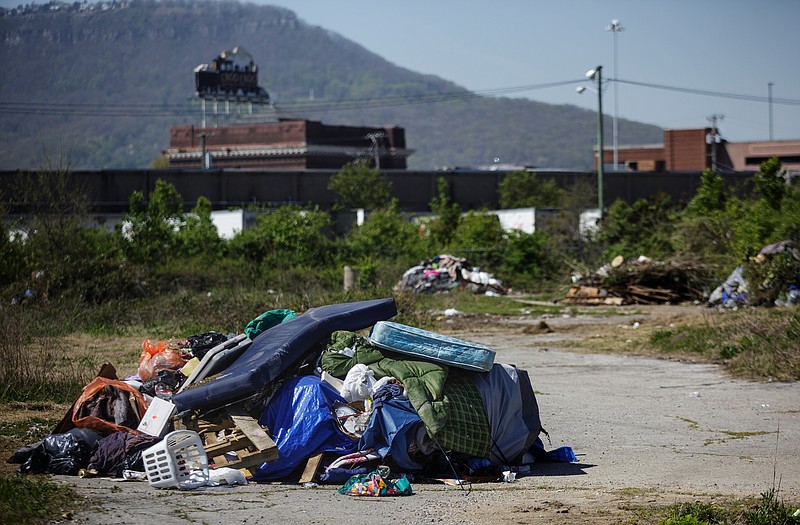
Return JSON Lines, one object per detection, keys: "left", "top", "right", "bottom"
{"left": 8, "top": 298, "right": 577, "bottom": 496}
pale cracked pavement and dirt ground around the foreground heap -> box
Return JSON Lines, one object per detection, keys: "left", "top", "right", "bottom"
{"left": 6, "top": 306, "right": 800, "bottom": 525}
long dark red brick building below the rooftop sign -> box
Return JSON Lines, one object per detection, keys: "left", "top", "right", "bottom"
{"left": 164, "top": 119, "right": 411, "bottom": 170}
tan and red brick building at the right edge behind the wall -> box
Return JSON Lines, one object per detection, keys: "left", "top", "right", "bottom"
{"left": 603, "top": 128, "right": 800, "bottom": 174}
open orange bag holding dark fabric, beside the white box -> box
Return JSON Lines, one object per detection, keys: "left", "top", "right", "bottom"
{"left": 72, "top": 377, "right": 147, "bottom": 435}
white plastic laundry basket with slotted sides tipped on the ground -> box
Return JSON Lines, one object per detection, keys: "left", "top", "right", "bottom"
{"left": 142, "top": 430, "right": 208, "bottom": 489}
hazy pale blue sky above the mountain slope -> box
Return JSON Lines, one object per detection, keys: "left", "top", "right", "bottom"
{"left": 256, "top": 0, "right": 800, "bottom": 145}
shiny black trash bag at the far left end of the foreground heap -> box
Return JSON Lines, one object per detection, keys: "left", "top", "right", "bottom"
{"left": 17, "top": 428, "right": 102, "bottom": 476}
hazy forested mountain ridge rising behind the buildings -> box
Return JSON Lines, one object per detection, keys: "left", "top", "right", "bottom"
{"left": 0, "top": 0, "right": 662, "bottom": 169}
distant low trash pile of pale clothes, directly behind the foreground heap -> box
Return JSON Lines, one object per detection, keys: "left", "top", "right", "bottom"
{"left": 394, "top": 254, "right": 508, "bottom": 295}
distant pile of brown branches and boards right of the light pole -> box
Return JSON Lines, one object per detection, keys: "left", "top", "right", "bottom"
{"left": 562, "top": 255, "right": 712, "bottom": 305}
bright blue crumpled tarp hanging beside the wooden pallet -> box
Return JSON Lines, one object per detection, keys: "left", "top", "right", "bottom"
{"left": 251, "top": 376, "right": 356, "bottom": 481}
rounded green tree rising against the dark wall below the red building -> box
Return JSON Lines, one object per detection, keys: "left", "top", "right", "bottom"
{"left": 328, "top": 160, "right": 392, "bottom": 210}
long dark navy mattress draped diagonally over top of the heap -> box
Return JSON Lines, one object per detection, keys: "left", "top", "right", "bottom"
{"left": 172, "top": 298, "right": 397, "bottom": 412}
